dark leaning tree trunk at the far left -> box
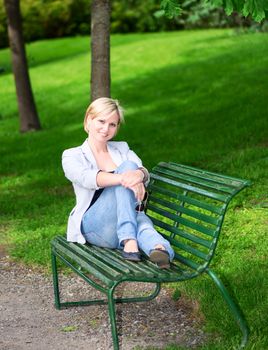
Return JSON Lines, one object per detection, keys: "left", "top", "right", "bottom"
{"left": 4, "top": 0, "right": 41, "bottom": 132}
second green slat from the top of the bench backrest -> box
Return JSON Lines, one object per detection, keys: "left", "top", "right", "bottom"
{"left": 154, "top": 166, "right": 236, "bottom": 194}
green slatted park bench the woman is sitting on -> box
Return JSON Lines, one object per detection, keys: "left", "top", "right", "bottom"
{"left": 51, "top": 162, "right": 250, "bottom": 349}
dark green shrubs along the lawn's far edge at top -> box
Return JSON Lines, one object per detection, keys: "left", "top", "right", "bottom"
{"left": 0, "top": 0, "right": 268, "bottom": 48}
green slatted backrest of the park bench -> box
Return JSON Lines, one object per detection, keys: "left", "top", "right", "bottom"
{"left": 146, "top": 162, "right": 250, "bottom": 278}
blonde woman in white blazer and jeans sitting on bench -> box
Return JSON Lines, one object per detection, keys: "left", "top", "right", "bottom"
{"left": 62, "top": 97, "right": 174, "bottom": 268}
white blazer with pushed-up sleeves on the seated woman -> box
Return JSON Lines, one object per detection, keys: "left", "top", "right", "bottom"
{"left": 62, "top": 140, "right": 147, "bottom": 244}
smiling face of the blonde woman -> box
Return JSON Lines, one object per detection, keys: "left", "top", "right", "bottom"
{"left": 88, "top": 111, "right": 119, "bottom": 142}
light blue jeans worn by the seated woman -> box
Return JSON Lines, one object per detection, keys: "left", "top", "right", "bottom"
{"left": 81, "top": 161, "right": 174, "bottom": 260}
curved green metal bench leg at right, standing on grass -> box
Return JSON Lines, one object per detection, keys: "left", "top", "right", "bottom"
{"left": 206, "top": 269, "right": 249, "bottom": 349}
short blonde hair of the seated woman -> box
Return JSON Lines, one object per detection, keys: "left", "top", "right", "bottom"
{"left": 84, "top": 97, "right": 124, "bottom": 132}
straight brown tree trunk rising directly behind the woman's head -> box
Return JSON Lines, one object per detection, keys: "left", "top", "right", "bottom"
{"left": 91, "top": 0, "right": 111, "bottom": 101}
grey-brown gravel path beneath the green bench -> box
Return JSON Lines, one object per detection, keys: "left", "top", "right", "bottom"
{"left": 0, "top": 254, "right": 205, "bottom": 350}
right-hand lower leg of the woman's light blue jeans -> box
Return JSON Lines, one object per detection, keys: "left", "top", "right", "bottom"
{"left": 137, "top": 212, "right": 174, "bottom": 261}
